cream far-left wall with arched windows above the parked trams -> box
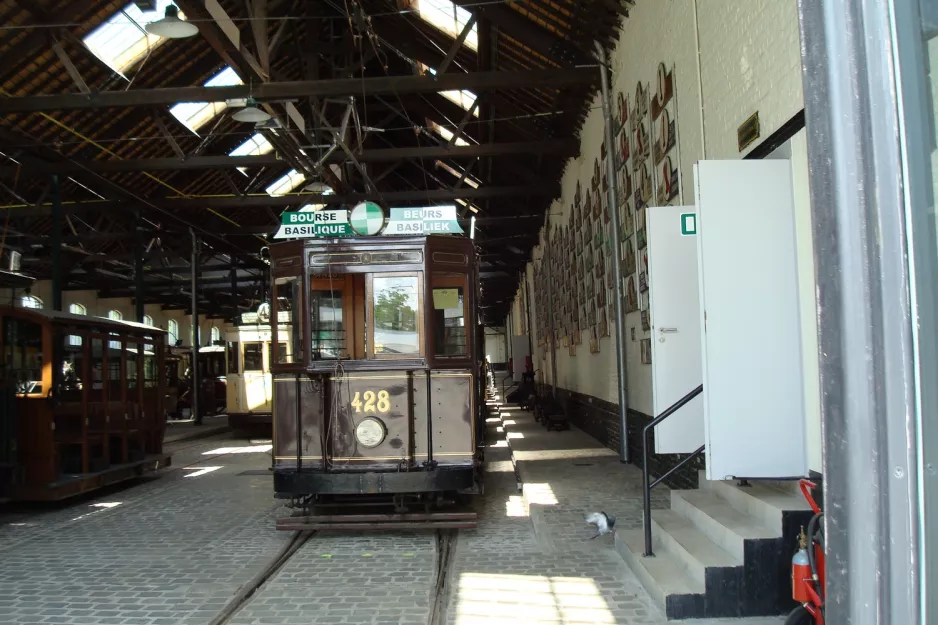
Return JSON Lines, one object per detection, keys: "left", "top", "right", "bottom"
{"left": 0, "top": 280, "right": 231, "bottom": 346}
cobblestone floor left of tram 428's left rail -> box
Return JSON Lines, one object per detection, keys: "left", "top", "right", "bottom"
{"left": 0, "top": 436, "right": 288, "bottom": 625}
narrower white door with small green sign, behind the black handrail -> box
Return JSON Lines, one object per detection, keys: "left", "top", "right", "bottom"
{"left": 645, "top": 206, "right": 704, "bottom": 454}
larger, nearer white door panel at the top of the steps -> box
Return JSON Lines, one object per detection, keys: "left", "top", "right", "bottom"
{"left": 694, "top": 160, "right": 807, "bottom": 480}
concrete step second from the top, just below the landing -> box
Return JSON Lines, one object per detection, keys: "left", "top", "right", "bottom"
{"left": 671, "top": 490, "right": 781, "bottom": 562}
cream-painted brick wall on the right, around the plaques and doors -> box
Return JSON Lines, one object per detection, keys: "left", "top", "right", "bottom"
{"left": 513, "top": 0, "right": 820, "bottom": 470}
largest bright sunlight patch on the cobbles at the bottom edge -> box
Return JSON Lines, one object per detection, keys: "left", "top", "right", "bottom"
{"left": 456, "top": 573, "right": 616, "bottom": 625}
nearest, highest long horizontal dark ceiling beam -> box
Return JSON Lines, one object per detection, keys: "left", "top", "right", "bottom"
{"left": 0, "top": 67, "right": 599, "bottom": 115}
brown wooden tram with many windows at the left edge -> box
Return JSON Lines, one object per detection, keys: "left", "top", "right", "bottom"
{"left": 0, "top": 307, "right": 170, "bottom": 501}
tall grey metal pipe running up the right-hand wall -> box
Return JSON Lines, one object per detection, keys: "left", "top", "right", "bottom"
{"left": 596, "top": 41, "right": 631, "bottom": 462}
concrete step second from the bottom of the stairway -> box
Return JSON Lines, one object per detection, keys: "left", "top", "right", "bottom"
{"left": 651, "top": 510, "right": 743, "bottom": 585}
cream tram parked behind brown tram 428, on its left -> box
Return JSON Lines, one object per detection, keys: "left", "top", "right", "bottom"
{"left": 225, "top": 301, "right": 294, "bottom": 435}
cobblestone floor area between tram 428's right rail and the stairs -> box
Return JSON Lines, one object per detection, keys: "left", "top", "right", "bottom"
{"left": 438, "top": 386, "right": 783, "bottom": 625}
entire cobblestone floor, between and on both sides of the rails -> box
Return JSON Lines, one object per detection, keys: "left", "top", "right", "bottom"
{"left": 0, "top": 392, "right": 780, "bottom": 625}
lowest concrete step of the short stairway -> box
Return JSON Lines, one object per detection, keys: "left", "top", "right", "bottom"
{"left": 615, "top": 529, "right": 704, "bottom": 618}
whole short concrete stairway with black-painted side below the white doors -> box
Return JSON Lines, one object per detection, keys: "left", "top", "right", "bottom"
{"left": 616, "top": 472, "right": 811, "bottom": 619}
